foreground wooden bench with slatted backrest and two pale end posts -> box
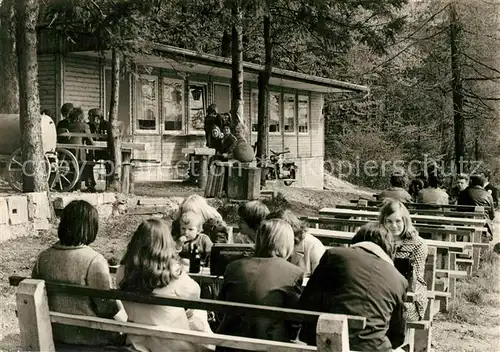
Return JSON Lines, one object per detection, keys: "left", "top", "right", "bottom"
{"left": 10, "top": 279, "right": 360, "bottom": 352}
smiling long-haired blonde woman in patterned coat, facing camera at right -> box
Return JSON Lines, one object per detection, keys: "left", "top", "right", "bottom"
{"left": 378, "top": 199, "right": 429, "bottom": 321}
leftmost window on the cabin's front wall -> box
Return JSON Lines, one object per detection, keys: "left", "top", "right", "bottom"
{"left": 136, "top": 76, "right": 158, "bottom": 132}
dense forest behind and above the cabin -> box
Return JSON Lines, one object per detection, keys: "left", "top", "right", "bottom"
{"left": 0, "top": 0, "right": 500, "bottom": 188}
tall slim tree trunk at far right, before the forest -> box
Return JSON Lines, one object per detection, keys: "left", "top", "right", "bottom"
{"left": 450, "top": 1, "right": 465, "bottom": 173}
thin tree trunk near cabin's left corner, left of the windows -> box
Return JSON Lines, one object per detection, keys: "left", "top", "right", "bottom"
{"left": 108, "top": 49, "right": 122, "bottom": 192}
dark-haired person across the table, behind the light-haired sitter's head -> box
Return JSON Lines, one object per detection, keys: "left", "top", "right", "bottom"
{"left": 233, "top": 200, "right": 269, "bottom": 243}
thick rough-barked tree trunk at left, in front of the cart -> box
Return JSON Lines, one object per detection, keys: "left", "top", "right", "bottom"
{"left": 16, "top": 0, "right": 48, "bottom": 192}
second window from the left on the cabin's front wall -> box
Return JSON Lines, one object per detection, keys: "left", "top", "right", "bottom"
{"left": 162, "top": 78, "right": 184, "bottom": 131}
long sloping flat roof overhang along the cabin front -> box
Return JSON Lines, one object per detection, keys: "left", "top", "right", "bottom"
{"left": 75, "top": 44, "right": 370, "bottom": 93}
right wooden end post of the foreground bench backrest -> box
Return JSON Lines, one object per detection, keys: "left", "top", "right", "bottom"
{"left": 316, "top": 314, "right": 350, "bottom": 352}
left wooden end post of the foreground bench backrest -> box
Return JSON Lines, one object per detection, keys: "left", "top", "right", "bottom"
{"left": 16, "top": 279, "right": 55, "bottom": 352}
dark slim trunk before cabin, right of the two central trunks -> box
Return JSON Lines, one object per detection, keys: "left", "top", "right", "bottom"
{"left": 257, "top": 11, "right": 273, "bottom": 186}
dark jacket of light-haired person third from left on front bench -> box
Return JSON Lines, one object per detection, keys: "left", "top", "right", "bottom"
{"left": 217, "top": 257, "right": 304, "bottom": 351}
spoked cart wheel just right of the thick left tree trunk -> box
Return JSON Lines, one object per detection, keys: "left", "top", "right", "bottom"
{"left": 50, "top": 148, "right": 80, "bottom": 192}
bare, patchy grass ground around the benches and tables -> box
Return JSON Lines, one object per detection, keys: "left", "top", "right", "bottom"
{"left": 0, "top": 180, "right": 500, "bottom": 352}
